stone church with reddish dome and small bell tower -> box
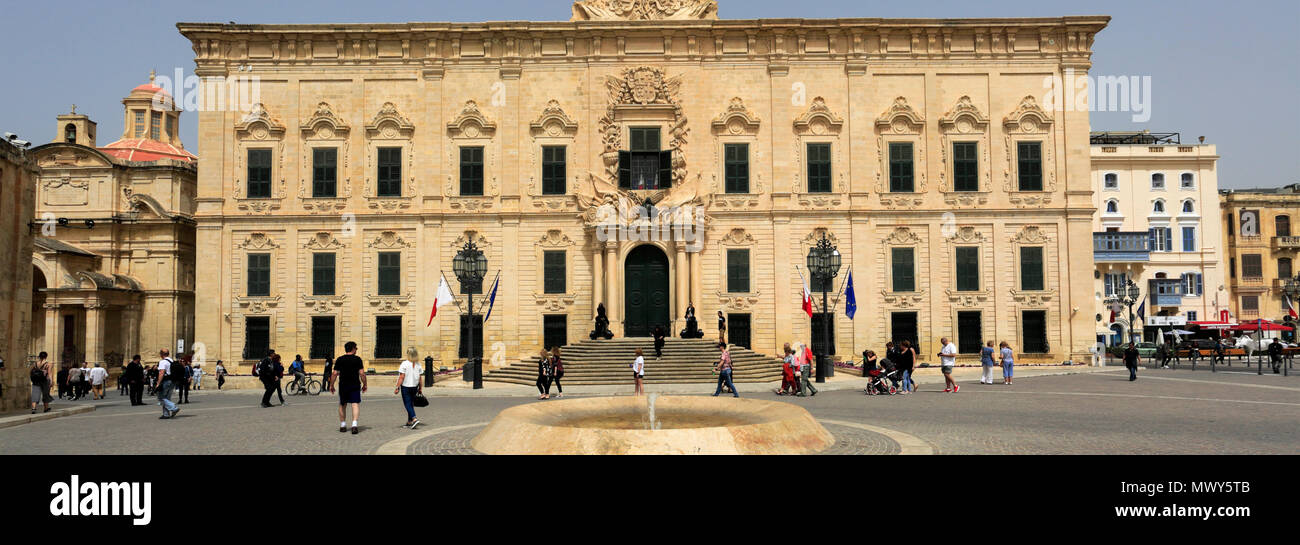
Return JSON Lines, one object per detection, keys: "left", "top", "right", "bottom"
{"left": 30, "top": 75, "right": 196, "bottom": 372}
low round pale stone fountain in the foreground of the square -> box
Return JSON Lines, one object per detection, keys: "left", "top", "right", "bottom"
{"left": 471, "top": 394, "right": 835, "bottom": 454}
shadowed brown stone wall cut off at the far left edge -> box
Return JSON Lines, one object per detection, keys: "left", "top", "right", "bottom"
{"left": 0, "top": 139, "right": 38, "bottom": 412}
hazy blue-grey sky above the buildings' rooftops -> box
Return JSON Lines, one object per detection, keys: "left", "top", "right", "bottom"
{"left": 0, "top": 0, "right": 1300, "bottom": 187}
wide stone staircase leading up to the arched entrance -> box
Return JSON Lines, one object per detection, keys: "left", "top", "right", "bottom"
{"left": 484, "top": 337, "right": 781, "bottom": 386}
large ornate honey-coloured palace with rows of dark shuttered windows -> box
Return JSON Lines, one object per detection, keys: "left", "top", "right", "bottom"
{"left": 178, "top": 0, "right": 1109, "bottom": 372}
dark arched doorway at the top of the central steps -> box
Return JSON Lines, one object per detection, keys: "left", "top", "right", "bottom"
{"left": 623, "top": 245, "right": 672, "bottom": 337}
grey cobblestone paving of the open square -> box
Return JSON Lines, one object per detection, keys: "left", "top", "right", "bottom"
{"left": 0, "top": 369, "right": 1300, "bottom": 454}
